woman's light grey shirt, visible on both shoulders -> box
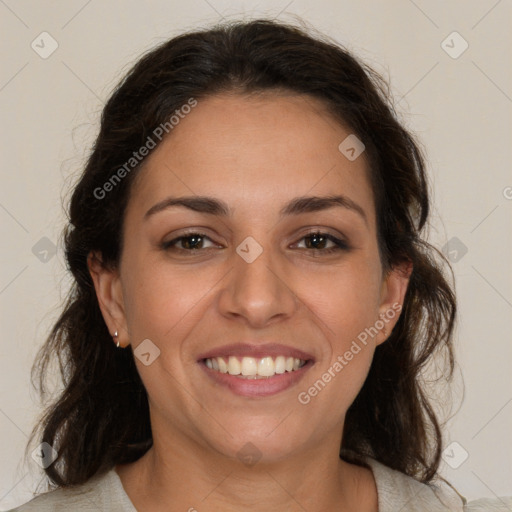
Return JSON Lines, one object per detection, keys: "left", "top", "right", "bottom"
{"left": 10, "top": 459, "right": 512, "bottom": 512}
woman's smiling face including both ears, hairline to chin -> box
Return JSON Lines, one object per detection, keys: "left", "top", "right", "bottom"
{"left": 93, "top": 93, "right": 407, "bottom": 461}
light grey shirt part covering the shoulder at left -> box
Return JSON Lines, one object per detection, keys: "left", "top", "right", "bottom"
{"left": 9, "top": 469, "right": 136, "bottom": 512}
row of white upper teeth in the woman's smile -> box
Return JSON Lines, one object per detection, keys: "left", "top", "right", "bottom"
{"left": 205, "top": 356, "right": 306, "bottom": 379}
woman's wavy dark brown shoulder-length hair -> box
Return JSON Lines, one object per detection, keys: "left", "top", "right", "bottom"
{"left": 30, "top": 20, "right": 456, "bottom": 487}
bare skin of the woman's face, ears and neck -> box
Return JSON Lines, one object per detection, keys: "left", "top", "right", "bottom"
{"left": 89, "top": 93, "right": 410, "bottom": 512}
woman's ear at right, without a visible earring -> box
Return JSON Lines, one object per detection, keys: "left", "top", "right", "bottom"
{"left": 375, "top": 261, "right": 412, "bottom": 345}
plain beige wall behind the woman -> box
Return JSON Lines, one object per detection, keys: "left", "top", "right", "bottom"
{"left": 0, "top": 0, "right": 512, "bottom": 510}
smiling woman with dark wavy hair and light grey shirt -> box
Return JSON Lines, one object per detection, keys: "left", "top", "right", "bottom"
{"left": 10, "top": 20, "right": 506, "bottom": 512}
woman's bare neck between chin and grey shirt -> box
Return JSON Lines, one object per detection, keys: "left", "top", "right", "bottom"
{"left": 117, "top": 426, "right": 377, "bottom": 512}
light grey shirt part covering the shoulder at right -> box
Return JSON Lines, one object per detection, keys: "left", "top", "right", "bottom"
{"left": 364, "top": 458, "right": 512, "bottom": 512}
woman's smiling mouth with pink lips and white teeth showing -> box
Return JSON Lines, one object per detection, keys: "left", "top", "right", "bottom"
{"left": 197, "top": 345, "right": 314, "bottom": 397}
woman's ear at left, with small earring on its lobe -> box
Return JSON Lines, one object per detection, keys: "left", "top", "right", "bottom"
{"left": 87, "top": 252, "right": 130, "bottom": 347}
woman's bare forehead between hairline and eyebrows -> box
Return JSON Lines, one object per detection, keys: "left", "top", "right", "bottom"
{"left": 130, "top": 93, "right": 374, "bottom": 224}
